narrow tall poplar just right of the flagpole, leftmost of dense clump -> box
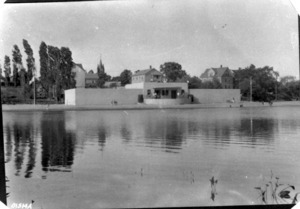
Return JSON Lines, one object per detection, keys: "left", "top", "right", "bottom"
{"left": 39, "top": 41, "right": 51, "bottom": 98}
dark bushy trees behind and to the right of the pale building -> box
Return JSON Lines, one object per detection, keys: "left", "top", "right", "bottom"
{"left": 139, "top": 62, "right": 300, "bottom": 102}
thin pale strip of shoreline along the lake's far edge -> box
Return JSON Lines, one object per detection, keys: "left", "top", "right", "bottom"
{"left": 2, "top": 101, "right": 300, "bottom": 112}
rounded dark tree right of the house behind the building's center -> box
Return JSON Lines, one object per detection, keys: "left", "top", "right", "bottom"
{"left": 160, "top": 62, "right": 187, "bottom": 82}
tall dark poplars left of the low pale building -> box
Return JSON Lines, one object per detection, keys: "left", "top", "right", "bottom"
{"left": 0, "top": 39, "right": 76, "bottom": 101}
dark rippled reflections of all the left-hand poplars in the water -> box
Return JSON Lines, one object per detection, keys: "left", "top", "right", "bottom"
{"left": 5, "top": 112, "right": 76, "bottom": 178}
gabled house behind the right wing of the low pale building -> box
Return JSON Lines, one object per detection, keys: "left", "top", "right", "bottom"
{"left": 200, "top": 65, "right": 234, "bottom": 89}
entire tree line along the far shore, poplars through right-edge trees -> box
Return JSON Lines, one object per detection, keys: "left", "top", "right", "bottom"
{"left": 0, "top": 39, "right": 300, "bottom": 102}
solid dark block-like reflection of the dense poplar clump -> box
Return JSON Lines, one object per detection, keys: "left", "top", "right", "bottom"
{"left": 41, "top": 112, "right": 76, "bottom": 171}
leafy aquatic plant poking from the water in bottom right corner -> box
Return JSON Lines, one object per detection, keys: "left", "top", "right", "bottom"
{"left": 254, "top": 171, "right": 300, "bottom": 204}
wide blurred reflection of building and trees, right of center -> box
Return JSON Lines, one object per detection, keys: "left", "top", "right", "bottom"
{"left": 134, "top": 111, "right": 278, "bottom": 152}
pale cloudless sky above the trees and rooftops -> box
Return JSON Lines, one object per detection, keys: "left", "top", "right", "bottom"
{"left": 0, "top": 0, "right": 299, "bottom": 78}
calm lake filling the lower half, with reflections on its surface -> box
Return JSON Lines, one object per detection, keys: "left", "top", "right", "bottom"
{"left": 3, "top": 106, "right": 300, "bottom": 208}
